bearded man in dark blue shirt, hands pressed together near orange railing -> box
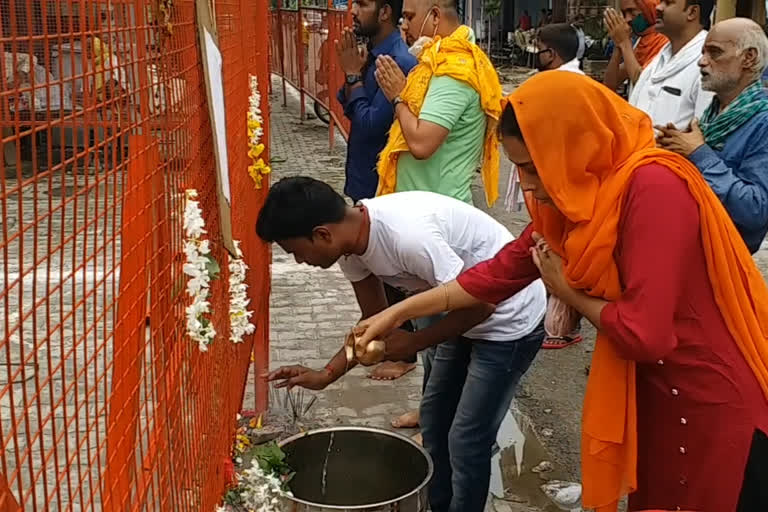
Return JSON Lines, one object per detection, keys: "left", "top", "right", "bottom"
{"left": 336, "top": 0, "right": 417, "bottom": 201}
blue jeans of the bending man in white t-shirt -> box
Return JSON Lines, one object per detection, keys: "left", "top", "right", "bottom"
{"left": 420, "top": 324, "right": 545, "bottom": 512}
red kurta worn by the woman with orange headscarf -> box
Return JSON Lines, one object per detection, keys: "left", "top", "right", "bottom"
{"left": 458, "top": 165, "right": 768, "bottom": 512}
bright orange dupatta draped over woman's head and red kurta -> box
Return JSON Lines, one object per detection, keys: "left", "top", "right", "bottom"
{"left": 502, "top": 71, "right": 768, "bottom": 512}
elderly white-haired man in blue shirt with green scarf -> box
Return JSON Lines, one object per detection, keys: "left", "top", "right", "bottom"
{"left": 657, "top": 18, "right": 768, "bottom": 254}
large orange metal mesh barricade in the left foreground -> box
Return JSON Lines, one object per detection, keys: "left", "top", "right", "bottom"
{"left": 0, "top": 0, "right": 272, "bottom": 512}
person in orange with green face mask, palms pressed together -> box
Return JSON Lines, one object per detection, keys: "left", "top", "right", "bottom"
{"left": 603, "top": 0, "right": 669, "bottom": 91}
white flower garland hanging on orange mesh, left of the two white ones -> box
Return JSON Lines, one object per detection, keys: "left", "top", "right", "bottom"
{"left": 183, "top": 189, "right": 216, "bottom": 352}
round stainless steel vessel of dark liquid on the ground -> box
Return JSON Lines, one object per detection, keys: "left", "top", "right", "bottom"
{"left": 280, "top": 426, "right": 433, "bottom": 512}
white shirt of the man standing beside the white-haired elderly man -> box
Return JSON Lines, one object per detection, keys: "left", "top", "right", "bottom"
{"left": 629, "top": 30, "right": 714, "bottom": 130}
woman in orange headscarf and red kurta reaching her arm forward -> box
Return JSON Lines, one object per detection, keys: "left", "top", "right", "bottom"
{"left": 356, "top": 71, "right": 768, "bottom": 512}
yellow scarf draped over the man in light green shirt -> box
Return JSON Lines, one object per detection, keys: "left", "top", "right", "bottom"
{"left": 376, "top": 25, "right": 501, "bottom": 206}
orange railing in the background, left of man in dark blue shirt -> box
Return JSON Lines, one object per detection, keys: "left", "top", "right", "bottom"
{"left": 269, "top": 0, "right": 349, "bottom": 144}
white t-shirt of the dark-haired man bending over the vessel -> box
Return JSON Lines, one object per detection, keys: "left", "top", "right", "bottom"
{"left": 339, "top": 192, "right": 547, "bottom": 341}
